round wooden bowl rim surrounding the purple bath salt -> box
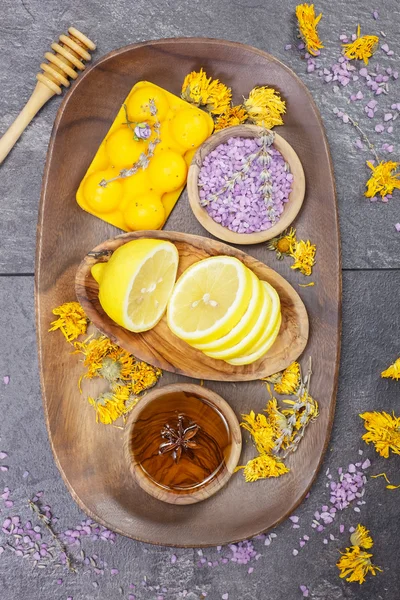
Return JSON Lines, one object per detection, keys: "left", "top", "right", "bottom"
{"left": 187, "top": 125, "right": 305, "bottom": 244}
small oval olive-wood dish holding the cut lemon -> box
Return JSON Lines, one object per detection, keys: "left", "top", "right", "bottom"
{"left": 75, "top": 231, "right": 308, "bottom": 381}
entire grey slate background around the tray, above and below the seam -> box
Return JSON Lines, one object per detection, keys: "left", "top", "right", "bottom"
{"left": 0, "top": 0, "right": 400, "bottom": 600}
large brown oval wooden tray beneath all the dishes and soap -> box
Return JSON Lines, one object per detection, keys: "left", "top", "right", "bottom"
{"left": 36, "top": 39, "right": 341, "bottom": 546}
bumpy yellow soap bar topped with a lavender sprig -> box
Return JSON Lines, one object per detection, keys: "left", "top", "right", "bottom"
{"left": 76, "top": 81, "right": 214, "bottom": 231}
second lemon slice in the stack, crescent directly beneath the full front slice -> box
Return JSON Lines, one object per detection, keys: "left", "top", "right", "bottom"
{"left": 193, "top": 272, "right": 264, "bottom": 352}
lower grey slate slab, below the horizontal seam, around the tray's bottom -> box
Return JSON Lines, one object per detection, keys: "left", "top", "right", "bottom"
{"left": 0, "top": 272, "right": 400, "bottom": 600}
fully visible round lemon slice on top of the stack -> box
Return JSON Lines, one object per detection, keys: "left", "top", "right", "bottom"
{"left": 167, "top": 256, "right": 253, "bottom": 344}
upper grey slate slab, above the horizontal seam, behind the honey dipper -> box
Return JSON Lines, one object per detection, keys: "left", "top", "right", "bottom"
{"left": 0, "top": 0, "right": 400, "bottom": 273}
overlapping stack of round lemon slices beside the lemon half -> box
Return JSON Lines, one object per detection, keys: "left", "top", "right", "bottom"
{"left": 167, "top": 256, "right": 282, "bottom": 365}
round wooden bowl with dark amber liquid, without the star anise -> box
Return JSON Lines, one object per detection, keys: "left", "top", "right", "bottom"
{"left": 124, "top": 383, "right": 242, "bottom": 504}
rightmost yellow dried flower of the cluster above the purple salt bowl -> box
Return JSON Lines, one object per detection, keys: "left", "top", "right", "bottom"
{"left": 243, "top": 86, "right": 286, "bottom": 129}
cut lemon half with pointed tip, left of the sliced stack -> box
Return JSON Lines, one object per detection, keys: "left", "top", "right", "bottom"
{"left": 92, "top": 239, "right": 179, "bottom": 332}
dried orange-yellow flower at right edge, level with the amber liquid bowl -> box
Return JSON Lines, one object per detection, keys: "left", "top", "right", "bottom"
{"left": 360, "top": 412, "right": 400, "bottom": 458}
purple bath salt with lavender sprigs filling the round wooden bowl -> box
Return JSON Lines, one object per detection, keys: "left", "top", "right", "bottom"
{"left": 198, "top": 132, "right": 293, "bottom": 233}
